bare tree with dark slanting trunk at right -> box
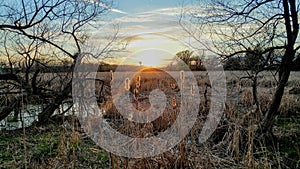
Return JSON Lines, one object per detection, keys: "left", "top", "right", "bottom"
{"left": 185, "top": 0, "right": 300, "bottom": 136}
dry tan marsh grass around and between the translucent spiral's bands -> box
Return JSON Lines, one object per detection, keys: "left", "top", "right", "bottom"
{"left": 0, "top": 72, "right": 300, "bottom": 169}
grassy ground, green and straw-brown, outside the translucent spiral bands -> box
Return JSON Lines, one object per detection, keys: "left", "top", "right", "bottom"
{"left": 0, "top": 72, "right": 300, "bottom": 168}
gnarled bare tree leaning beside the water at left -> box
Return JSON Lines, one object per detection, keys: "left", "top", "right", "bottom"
{"left": 0, "top": 0, "right": 111, "bottom": 122}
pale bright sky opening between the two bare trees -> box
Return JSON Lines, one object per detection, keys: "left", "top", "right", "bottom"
{"left": 92, "top": 0, "right": 206, "bottom": 67}
